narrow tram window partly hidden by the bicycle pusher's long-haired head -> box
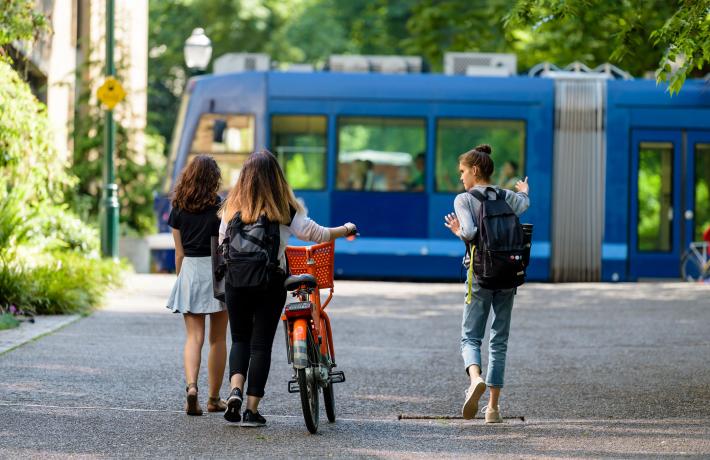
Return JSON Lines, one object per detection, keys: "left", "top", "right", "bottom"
{"left": 271, "top": 115, "right": 327, "bottom": 190}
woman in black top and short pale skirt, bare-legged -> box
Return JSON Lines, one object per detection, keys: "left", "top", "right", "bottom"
{"left": 167, "top": 155, "right": 228, "bottom": 415}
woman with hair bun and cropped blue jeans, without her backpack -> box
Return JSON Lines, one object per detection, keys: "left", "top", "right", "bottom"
{"left": 444, "top": 144, "right": 530, "bottom": 423}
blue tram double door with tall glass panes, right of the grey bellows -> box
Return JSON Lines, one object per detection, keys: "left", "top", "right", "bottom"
{"left": 629, "top": 130, "right": 710, "bottom": 278}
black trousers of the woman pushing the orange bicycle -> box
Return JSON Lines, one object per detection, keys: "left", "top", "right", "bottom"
{"left": 225, "top": 274, "right": 286, "bottom": 398}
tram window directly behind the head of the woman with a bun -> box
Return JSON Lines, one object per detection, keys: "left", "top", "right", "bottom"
{"left": 436, "top": 118, "right": 525, "bottom": 193}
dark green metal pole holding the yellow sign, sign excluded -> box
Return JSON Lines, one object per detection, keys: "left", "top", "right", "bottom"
{"left": 101, "top": 0, "right": 118, "bottom": 259}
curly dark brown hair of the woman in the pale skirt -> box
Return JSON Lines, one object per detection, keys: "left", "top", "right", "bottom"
{"left": 172, "top": 155, "right": 222, "bottom": 213}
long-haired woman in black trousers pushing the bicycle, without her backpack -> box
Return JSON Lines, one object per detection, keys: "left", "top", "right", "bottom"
{"left": 219, "top": 151, "right": 355, "bottom": 427}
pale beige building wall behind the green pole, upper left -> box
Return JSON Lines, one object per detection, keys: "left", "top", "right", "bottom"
{"left": 16, "top": 0, "right": 148, "bottom": 163}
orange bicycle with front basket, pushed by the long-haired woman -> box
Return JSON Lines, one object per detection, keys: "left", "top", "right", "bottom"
{"left": 281, "top": 241, "right": 345, "bottom": 433}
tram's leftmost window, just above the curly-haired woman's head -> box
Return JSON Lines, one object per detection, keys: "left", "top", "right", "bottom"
{"left": 186, "top": 113, "right": 254, "bottom": 191}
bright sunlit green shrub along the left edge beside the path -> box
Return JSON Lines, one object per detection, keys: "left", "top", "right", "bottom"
{"left": 0, "top": 51, "right": 125, "bottom": 314}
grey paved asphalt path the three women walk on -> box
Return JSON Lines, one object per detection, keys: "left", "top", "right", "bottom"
{"left": 0, "top": 275, "right": 710, "bottom": 458}
